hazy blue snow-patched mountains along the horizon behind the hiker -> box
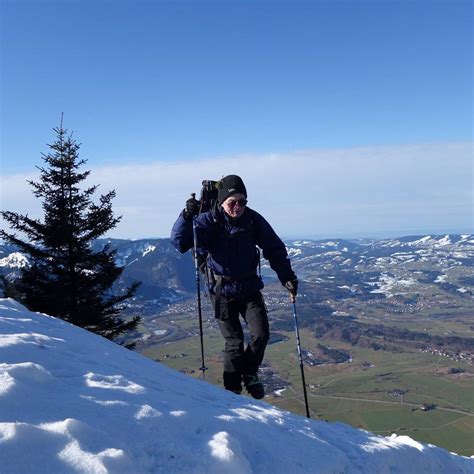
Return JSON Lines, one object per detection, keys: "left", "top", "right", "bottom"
{"left": 0, "top": 234, "right": 474, "bottom": 312}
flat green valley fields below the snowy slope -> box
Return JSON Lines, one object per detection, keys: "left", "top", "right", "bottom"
{"left": 139, "top": 321, "right": 474, "bottom": 456}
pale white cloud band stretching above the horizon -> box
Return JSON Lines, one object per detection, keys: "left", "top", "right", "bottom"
{"left": 2, "top": 143, "right": 473, "bottom": 238}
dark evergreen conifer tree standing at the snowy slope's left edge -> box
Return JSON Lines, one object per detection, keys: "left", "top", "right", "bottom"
{"left": 0, "top": 124, "right": 140, "bottom": 339}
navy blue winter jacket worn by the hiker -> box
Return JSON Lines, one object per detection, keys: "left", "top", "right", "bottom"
{"left": 171, "top": 207, "right": 296, "bottom": 298}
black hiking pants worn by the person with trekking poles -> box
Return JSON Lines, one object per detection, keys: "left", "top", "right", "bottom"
{"left": 214, "top": 292, "right": 270, "bottom": 391}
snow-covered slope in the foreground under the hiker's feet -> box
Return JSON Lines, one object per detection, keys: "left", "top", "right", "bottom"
{"left": 0, "top": 299, "right": 474, "bottom": 474}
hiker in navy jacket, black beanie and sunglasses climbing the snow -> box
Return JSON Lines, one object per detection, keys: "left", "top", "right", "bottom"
{"left": 171, "top": 175, "right": 298, "bottom": 399}
